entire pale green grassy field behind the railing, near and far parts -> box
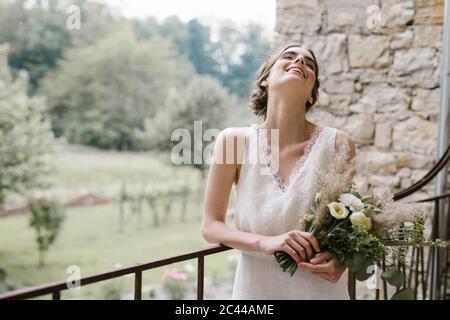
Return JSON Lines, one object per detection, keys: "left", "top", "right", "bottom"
{"left": 0, "top": 145, "right": 235, "bottom": 299}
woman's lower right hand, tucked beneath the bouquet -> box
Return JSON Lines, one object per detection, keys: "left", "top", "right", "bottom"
{"left": 298, "top": 251, "right": 346, "bottom": 283}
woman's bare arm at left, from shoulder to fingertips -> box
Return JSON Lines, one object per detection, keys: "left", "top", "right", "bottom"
{"left": 202, "top": 128, "right": 320, "bottom": 263}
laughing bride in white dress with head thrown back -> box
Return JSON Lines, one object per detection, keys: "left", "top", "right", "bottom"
{"left": 202, "top": 44, "right": 355, "bottom": 299}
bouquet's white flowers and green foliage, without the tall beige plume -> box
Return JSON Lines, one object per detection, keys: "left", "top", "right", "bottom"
{"left": 275, "top": 184, "right": 425, "bottom": 280}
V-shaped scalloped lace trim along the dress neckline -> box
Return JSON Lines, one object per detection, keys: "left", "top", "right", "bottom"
{"left": 260, "top": 125, "right": 324, "bottom": 192}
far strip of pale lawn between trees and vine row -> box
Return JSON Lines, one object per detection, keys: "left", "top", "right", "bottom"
{"left": 3, "top": 143, "right": 204, "bottom": 203}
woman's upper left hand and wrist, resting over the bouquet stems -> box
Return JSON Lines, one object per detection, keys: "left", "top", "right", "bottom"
{"left": 261, "top": 230, "right": 320, "bottom": 264}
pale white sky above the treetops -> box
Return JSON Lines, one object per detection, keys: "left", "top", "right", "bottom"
{"left": 100, "top": 0, "right": 276, "bottom": 37}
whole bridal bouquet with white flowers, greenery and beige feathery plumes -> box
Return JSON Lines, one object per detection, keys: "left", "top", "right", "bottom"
{"left": 274, "top": 139, "right": 446, "bottom": 298}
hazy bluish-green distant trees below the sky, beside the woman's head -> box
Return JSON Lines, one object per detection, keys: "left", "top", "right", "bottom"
{"left": 134, "top": 16, "right": 270, "bottom": 99}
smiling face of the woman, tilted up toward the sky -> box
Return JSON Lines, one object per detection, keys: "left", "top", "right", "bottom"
{"left": 263, "top": 47, "right": 317, "bottom": 101}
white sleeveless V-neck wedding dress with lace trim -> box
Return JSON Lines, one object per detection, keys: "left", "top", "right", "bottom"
{"left": 232, "top": 124, "right": 349, "bottom": 300}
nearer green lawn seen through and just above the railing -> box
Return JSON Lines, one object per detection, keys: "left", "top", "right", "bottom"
{"left": 0, "top": 204, "right": 237, "bottom": 298}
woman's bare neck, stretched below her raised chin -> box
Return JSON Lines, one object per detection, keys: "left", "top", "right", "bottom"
{"left": 263, "top": 94, "right": 313, "bottom": 149}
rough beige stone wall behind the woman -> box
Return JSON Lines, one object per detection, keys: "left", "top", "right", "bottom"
{"left": 275, "top": 0, "right": 444, "bottom": 199}
